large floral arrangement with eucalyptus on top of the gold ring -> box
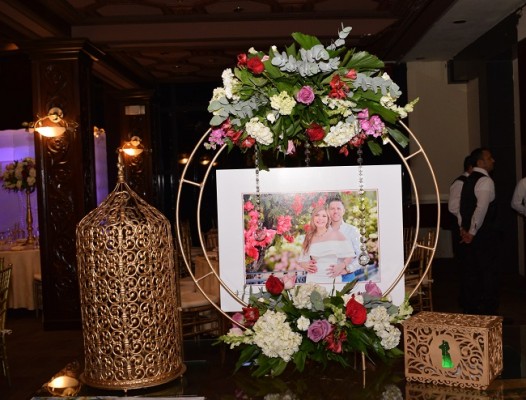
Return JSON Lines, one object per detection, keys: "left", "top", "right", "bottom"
{"left": 205, "top": 26, "right": 418, "bottom": 155}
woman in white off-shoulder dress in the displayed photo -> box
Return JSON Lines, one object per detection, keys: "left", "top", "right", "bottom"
{"left": 299, "top": 206, "right": 356, "bottom": 283}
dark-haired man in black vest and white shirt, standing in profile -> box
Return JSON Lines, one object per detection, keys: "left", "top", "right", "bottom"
{"left": 460, "top": 148, "right": 499, "bottom": 315}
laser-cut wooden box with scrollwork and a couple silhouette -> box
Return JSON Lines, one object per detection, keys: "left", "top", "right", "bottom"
{"left": 403, "top": 311, "right": 503, "bottom": 389}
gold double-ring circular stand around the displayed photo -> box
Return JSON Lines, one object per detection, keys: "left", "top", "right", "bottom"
{"left": 175, "top": 122, "right": 440, "bottom": 322}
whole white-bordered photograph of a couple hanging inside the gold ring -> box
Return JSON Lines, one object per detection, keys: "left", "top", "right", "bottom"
{"left": 217, "top": 165, "right": 405, "bottom": 312}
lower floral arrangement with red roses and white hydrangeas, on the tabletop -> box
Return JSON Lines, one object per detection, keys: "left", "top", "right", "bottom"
{"left": 219, "top": 276, "right": 413, "bottom": 376}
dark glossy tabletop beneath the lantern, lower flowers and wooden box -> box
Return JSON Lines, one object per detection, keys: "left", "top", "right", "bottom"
{"left": 27, "top": 334, "right": 526, "bottom": 400}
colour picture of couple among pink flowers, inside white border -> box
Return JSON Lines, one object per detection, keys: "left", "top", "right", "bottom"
{"left": 244, "top": 190, "right": 380, "bottom": 285}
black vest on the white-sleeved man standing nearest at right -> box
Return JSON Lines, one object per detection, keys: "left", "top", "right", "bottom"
{"left": 460, "top": 171, "right": 497, "bottom": 235}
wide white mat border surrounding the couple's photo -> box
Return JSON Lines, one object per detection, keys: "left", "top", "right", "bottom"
{"left": 216, "top": 165, "right": 405, "bottom": 312}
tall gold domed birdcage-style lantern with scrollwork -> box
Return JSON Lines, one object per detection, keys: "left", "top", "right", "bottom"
{"left": 77, "top": 157, "right": 186, "bottom": 390}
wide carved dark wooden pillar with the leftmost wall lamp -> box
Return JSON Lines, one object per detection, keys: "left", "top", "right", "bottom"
{"left": 27, "top": 41, "right": 97, "bottom": 329}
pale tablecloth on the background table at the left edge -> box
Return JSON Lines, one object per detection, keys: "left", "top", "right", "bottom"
{"left": 0, "top": 249, "right": 41, "bottom": 310}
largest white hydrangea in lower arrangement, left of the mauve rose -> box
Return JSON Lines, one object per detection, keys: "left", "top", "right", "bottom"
{"left": 253, "top": 311, "right": 302, "bottom": 362}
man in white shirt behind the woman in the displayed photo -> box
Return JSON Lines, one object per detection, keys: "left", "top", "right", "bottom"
{"left": 328, "top": 197, "right": 362, "bottom": 282}
